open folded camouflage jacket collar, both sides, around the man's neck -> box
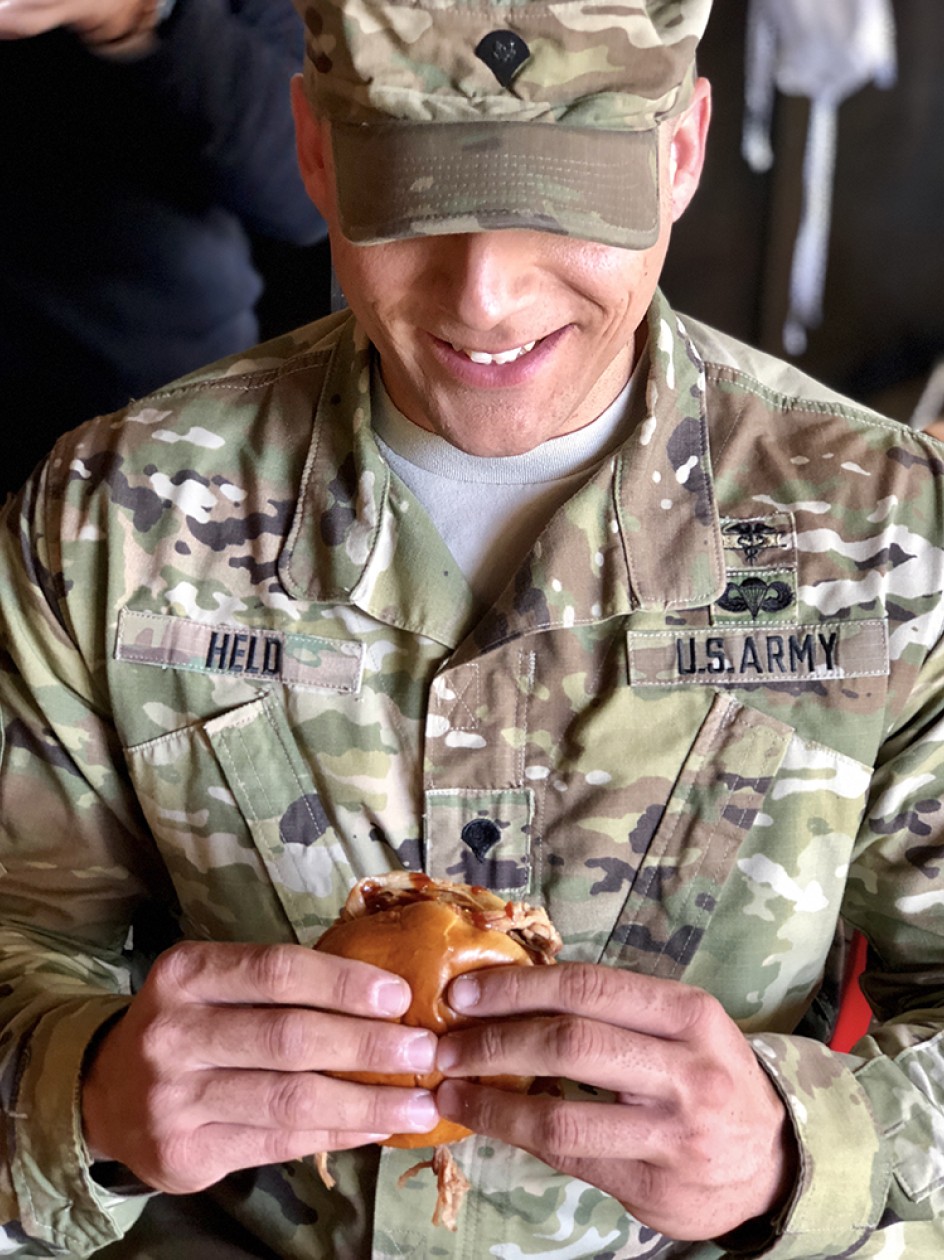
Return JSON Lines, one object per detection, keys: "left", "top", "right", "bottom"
{"left": 280, "top": 294, "right": 725, "bottom": 649}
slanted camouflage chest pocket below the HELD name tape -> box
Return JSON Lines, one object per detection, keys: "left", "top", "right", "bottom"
{"left": 126, "top": 692, "right": 376, "bottom": 944}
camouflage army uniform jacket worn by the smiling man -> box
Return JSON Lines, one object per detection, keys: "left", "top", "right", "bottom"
{"left": 0, "top": 288, "right": 944, "bottom": 1260}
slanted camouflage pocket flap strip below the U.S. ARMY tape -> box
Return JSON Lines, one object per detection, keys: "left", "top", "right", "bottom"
{"left": 600, "top": 692, "right": 794, "bottom": 979}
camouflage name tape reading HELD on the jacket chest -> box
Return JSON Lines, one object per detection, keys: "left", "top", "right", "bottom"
{"left": 115, "top": 609, "right": 364, "bottom": 694}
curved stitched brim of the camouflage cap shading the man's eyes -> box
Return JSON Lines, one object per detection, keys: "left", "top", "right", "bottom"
{"left": 331, "top": 122, "right": 659, "bottom": 249}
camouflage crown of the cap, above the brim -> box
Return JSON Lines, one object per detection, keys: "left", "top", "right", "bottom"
{"left": 296, "top": 0, "right": 711, "bottom": 131}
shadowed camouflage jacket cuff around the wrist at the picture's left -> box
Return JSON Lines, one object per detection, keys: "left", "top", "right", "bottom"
{"left": 11, "top": 995, "right": 151, "bottom": 1255}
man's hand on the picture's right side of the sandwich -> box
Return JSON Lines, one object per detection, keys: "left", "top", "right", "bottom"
{"left": 437, "top": 963, "right": 797, "bottom": 1240}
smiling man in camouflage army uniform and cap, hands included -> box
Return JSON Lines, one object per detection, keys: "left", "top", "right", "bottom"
{"left": 0, "top": 0, "right": 944, "bottom": 1260}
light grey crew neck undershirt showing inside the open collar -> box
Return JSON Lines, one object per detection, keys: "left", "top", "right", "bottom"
{"left": 371, "top": 367, "right": 636, "bottom": 604}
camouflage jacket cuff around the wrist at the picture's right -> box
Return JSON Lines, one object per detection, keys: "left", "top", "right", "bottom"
{"left": 749, "top": 1033, "right": 891, "bottom": 1260}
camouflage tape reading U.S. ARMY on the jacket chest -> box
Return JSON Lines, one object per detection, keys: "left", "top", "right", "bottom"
{"left": 626, "top": 619, "right": 889, "bottom": 687}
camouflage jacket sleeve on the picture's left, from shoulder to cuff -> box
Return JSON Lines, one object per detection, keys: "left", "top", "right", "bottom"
{"left": 0, "top": 461, "right": 162, "bottom": 1256}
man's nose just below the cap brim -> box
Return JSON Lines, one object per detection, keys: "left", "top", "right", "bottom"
{"left": 441, "top": 231, "right": 534, "bottom": 331}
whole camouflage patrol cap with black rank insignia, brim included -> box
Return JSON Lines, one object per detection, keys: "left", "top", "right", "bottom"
{"left": 295, "top": 0, "right": 712, "bottom": 249}
